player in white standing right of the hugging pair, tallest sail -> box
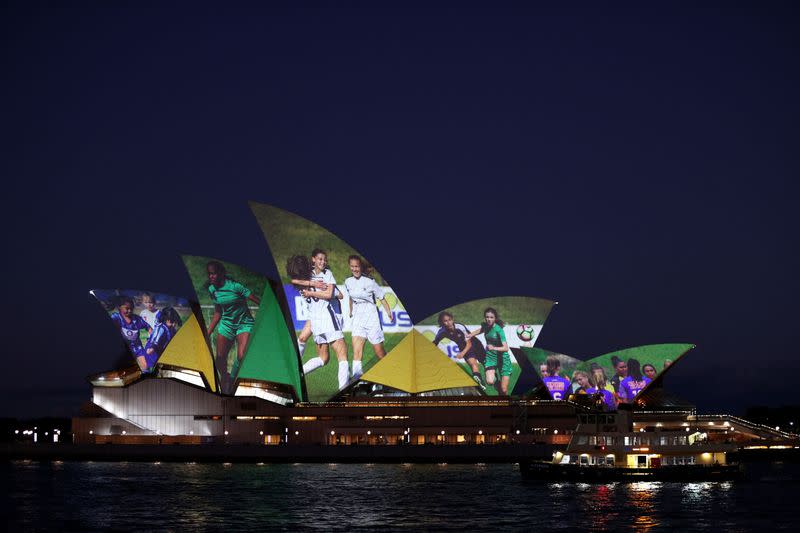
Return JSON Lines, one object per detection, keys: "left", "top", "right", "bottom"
{"left": 344, "top": 255, "right": 394, "bottom": 379}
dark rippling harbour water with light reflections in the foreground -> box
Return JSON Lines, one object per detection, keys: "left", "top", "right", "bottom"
{"left": 2, "top": 461, "right": 800, "bottom": 531}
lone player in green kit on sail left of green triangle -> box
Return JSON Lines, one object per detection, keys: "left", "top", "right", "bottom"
{"left": 206, "top": 261, "right": 261, "bottom": 393}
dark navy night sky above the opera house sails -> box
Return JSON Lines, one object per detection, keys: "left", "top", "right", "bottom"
{"left": 0, "top": 2, "right": 800, "bottom": 416}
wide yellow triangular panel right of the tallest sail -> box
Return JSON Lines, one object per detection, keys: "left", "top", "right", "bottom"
{"left": 361, "top": 330, "right": 476, "bottom": 393}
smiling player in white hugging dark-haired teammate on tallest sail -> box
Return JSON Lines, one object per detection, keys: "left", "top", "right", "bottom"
{"left": 301, "top": 249, "right": 350, "bottom": 389}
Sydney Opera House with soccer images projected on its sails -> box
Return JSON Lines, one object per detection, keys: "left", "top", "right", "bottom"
{"left": 73, "top": 203, "right": 794, "bottom": 465}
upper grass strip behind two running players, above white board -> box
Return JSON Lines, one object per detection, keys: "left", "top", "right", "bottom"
{"left": 418, "top": 296, "right": 553, "bottom": 326}
